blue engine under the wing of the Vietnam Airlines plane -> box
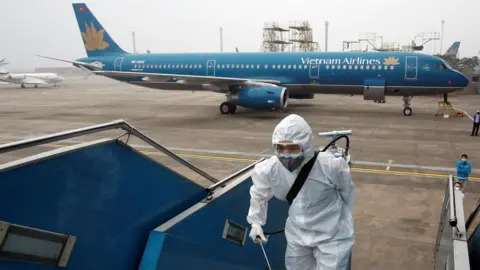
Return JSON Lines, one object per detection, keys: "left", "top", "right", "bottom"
{"left": 236, "top": 86, "right": 289, "bottom": 110}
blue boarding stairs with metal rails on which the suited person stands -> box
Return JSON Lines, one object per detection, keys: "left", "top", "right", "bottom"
{"left": 0, "top": 120, "right": 480, "bottom": 270}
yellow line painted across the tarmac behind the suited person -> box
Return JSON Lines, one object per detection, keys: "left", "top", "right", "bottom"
{"left": 0, "top": 140, "right": 480, "bottom": 181}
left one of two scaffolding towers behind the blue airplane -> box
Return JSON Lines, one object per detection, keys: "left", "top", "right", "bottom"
{"left": 261, "top": 22, "right": 291, "bottom": 52}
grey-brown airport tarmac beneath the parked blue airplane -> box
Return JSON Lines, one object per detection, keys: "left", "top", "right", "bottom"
{"left": 0, "top": 75, "right": 480, "bottom": 270}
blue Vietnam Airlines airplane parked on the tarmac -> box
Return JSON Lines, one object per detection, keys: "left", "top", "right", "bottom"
{"left": 38, "top": 3, "right": 469, "bottom": 116}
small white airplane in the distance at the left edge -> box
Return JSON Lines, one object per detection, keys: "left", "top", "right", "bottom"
{"left": 0, "top": 58, "right": 64, "bottom": 88}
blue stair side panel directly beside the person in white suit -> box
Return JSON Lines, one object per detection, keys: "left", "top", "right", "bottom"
{"left": 149, "top": 178, "right": 288, "bottom": 270}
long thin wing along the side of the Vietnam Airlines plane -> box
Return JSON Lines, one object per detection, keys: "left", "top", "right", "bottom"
{"left": 93, "top": 71, "right": 281, "bottom": 85}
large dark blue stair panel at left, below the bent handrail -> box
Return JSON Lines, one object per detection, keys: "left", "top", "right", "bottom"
{"left": 0, "top": 142, "right": 206, "bottom": 270}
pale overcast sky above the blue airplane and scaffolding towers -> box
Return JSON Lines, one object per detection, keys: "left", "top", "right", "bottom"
{"left": 0, "top": 0, "right": 480, "bottom": 71}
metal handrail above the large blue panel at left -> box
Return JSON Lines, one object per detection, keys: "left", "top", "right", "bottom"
{"left": 0, "top": 119, "right": 218, "bottom": 183}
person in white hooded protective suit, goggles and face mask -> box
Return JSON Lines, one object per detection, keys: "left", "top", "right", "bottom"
{"left": 247, "top": 114, "right": 355, "bottom": 270}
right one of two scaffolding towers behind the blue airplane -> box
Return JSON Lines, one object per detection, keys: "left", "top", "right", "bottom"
{"left": 289, "top": 21, "right": 318, "bottom": 52}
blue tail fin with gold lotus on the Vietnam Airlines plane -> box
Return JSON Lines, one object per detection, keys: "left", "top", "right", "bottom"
{"left": 72, "top": 3, "right": 127, "bottom": 57}
